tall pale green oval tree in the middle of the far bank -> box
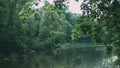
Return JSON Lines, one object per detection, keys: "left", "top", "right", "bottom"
{"left": 39, "top": 4, "right": 70, "bottom": 47}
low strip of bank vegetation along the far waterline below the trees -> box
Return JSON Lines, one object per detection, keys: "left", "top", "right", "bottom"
{"left": 0, "top": 43, "right": 104, "bottom": 61}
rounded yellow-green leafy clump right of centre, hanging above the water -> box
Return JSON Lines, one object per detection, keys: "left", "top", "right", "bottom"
{"left": 71, "top": 16, "right": 96, "bottom": 42}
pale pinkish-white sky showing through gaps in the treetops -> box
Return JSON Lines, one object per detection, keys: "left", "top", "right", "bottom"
{"left": 35, "top": 0, "right": 83, "bottom": 14}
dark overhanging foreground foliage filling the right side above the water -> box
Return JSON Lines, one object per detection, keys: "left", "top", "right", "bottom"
{"left": 73, "top": 0, "right": 120, "bottom": 65}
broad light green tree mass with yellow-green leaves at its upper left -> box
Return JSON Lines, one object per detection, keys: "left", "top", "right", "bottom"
{"left": 20, "top": 1, "right": 71, "bottom": 50}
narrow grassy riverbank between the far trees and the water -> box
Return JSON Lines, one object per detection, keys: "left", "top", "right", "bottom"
{"left": 0, "top": 43, "right": 104, "bottom": 60}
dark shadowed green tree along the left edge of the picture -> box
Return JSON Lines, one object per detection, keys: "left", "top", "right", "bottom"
{"left": 0, "top": 0, "right": 32, "bottom": 57}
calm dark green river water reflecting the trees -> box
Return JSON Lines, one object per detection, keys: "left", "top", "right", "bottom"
{"left": 0, "top": 47, "right": 104, "bottom": 68}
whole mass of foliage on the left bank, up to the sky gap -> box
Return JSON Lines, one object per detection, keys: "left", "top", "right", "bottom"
{"left": 0, "top": 0, "right": 75, "bottom": 58}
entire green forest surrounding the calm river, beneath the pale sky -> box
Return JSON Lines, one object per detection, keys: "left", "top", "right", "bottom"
{"left": 0, "top": 0, "right": 120, "bottom": 68}
